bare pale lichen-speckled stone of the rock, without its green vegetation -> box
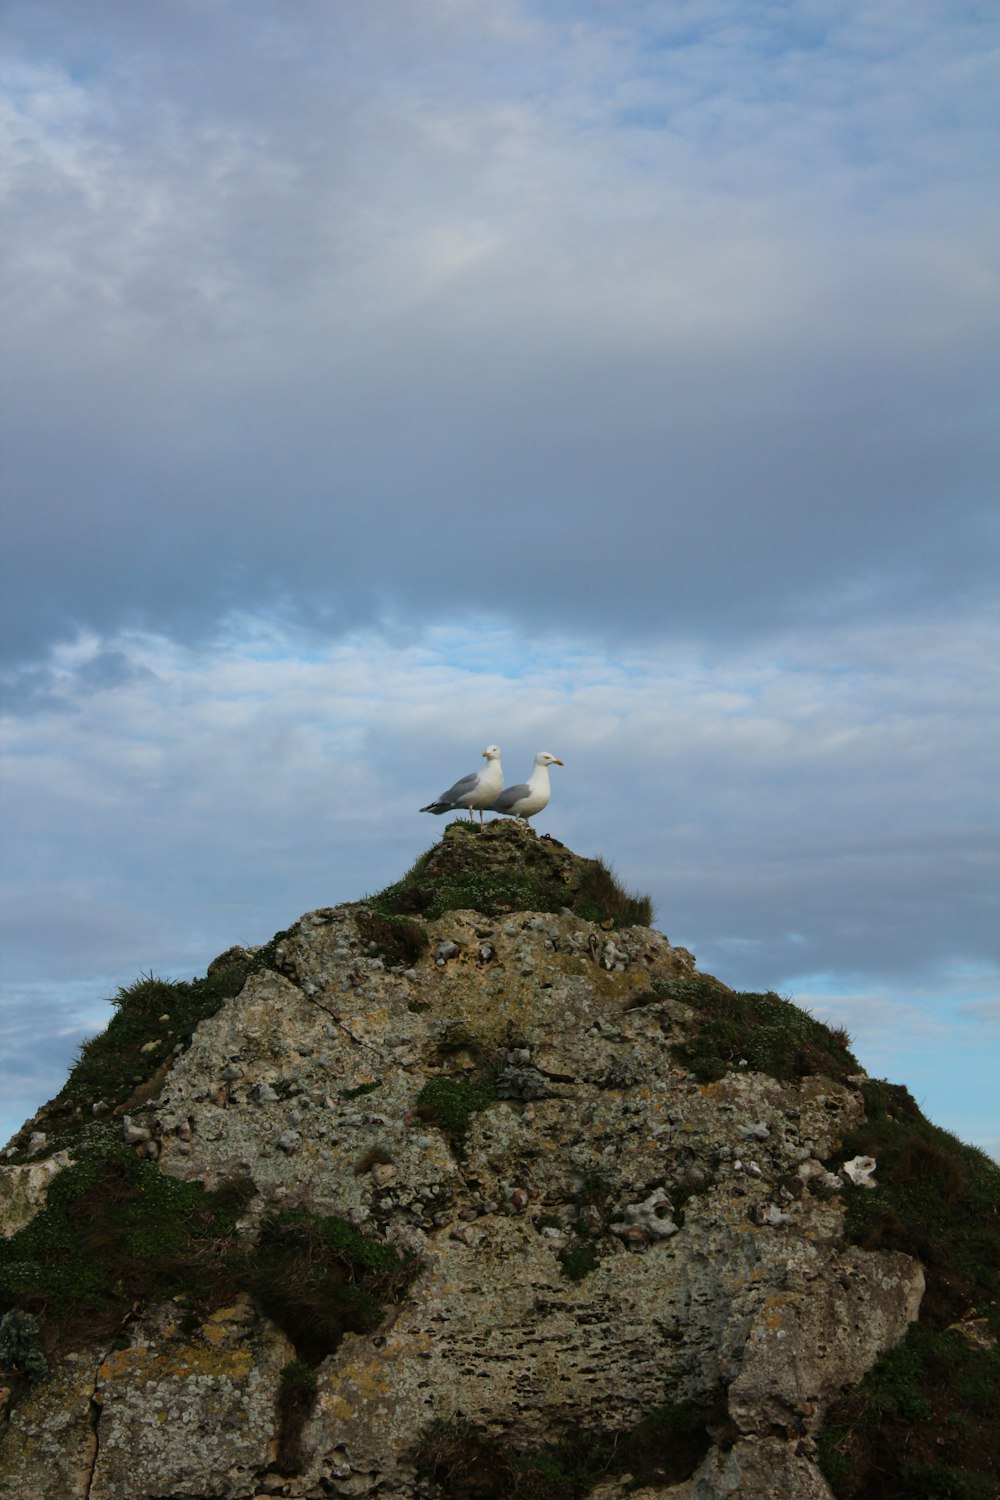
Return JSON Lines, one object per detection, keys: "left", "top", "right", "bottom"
{"left": 0, "top": 825, "right": 924, "bottom": 1500}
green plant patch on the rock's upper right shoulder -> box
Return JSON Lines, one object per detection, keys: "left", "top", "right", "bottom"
{"left": 670, "top": 977, "right": 861, "bottom": 1083}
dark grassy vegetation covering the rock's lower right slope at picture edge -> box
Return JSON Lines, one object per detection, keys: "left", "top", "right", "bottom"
{"left": 820, "top": 1082, "right": 1000, "bottom": 1500}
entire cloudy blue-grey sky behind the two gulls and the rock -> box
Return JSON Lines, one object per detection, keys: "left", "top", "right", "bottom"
{"left": 0, "top": 0, "right": 1000, "bottom": 1151}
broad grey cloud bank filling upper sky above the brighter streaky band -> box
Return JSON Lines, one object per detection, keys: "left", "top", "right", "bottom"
{"left": 4, "top": 0, "right": 996, "bottom": 654}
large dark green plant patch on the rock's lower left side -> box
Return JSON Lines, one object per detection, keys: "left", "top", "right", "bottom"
{"left": 0, "top": 1125, "right": 417, "bottom": 1364}
